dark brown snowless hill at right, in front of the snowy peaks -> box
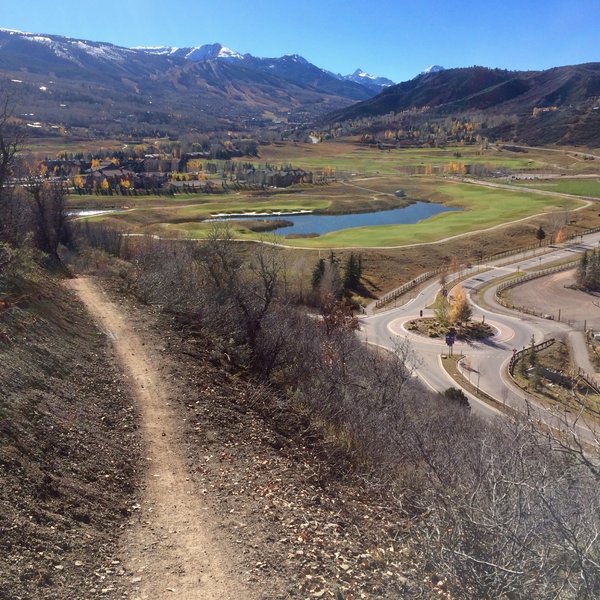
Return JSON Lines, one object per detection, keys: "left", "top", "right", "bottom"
{"left": 325, "top": 63, "right": 600, "bottom": 146}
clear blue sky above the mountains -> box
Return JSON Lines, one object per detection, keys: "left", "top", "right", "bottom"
{"left": 0, "top": 0, "right": 600, "bottom": 81}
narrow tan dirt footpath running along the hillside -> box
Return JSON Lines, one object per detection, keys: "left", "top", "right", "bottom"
{"left": 68, "top": 278, "right": 254, "bottom": 600}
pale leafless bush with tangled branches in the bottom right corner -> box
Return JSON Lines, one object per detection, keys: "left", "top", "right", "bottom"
{"left": 412, "top": 422, "right": 600, "bottom": 599}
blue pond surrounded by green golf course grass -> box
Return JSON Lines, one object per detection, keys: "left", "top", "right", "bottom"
{"left": 210, "top": 202, "right": 462, "bottom": 236}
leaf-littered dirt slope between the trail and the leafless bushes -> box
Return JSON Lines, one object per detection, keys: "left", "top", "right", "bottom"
{"left": 83, "top": 278, "right": 418, "bottom": 600}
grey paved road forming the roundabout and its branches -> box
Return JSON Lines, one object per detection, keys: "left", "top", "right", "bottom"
{"left": 361, "top": 233, "right": 600, "bottom": 436}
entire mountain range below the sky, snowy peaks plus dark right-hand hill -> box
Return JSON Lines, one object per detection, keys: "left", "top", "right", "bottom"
{"left": 0, "top": 29, "right": 600, "bottom": 145}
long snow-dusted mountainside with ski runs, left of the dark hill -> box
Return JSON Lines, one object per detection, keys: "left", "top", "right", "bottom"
{"left": 0, "top": 30, "right": 373, "bottom": 135}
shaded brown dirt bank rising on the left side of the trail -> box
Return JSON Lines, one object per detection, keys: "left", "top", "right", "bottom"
{"left": 0, "top": 281, "right": 140, "bottom": 600}
